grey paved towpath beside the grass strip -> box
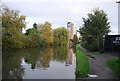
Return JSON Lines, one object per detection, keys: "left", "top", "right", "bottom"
{"left": 80, "top": 46, "right": 117, "bottom": 79}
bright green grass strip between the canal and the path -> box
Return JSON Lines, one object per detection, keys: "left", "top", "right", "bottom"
{"left": 76, "top": 45, "right": 90, "bottom": 78}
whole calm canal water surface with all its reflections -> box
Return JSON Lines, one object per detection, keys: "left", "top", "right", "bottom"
{"left": 2, "top": 46, "right": 76, "bottom": 79}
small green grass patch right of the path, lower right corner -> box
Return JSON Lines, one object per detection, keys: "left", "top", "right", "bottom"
{"left": 107, "top": 57, "right": 120, "bottom": 78}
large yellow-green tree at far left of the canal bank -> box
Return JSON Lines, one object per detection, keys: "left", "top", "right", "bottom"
{"left": 2, "top": 8, "right": 26, "bottom": 49}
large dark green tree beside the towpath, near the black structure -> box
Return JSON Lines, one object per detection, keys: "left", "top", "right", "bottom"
{"left": 79, "top": 8, "right": 110, "bottom": 51}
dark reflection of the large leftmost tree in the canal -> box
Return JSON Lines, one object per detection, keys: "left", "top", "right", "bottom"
{"left": 2, "top": 50, "right": 24, "bottom": 79}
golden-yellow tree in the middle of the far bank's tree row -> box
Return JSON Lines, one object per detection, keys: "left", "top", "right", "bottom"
{"left": 40, "top": 22, "right": 53, "bottom": 45}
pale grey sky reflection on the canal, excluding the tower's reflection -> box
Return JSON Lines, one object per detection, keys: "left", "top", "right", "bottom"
{"left": 23, "top": 62, "right": 75, "bottom": 79}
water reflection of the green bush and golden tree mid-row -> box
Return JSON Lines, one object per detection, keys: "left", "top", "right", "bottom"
{"left": 24, "top": 48, "right": 52, "bottom": 69}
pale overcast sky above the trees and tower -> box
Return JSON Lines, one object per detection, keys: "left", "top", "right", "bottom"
{"left": 2, "top": 0, "right": 118, "bottom": 35}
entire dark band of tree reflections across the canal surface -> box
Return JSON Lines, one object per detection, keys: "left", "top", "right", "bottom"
{"left": 2, "top": 46, "right": 73, "bottom": 79}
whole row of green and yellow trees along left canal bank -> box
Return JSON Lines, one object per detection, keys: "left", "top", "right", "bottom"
{"left": 2, "top": 8, "right": 68, "bottom": 49}
